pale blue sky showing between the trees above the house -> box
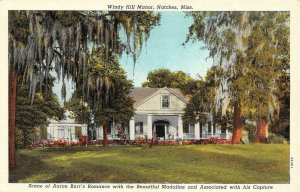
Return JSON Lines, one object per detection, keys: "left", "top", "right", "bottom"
{"left": 53, "top": 11, "right": 212, "bottom": 103}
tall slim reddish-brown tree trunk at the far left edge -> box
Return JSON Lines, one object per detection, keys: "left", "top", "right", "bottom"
{"left": 8, "top": 72, "right": 17, "bottom": 170}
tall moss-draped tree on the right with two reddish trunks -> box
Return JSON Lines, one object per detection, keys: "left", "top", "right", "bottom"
{"left": 187, "top": 12, "right": 289, "bottom": 143}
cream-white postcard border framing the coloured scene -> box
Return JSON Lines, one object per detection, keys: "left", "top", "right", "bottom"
{"left": 0, "top": 0, "right": 300, "bottom": 192}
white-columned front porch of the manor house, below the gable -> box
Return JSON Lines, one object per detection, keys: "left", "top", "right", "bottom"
{"left": 96, "top": 113, "right": 231, "bottom": 141}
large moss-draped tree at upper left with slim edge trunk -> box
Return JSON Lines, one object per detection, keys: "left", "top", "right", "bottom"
{"left": 8, "top": 11, "right": 160, "bottom": 169}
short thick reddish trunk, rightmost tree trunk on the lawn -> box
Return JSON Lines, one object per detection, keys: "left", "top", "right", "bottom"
{"left": 254, "top": 117, "right": 268, "bottom": 143}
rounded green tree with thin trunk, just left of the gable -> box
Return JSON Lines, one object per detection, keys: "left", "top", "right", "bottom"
{"left": 65, "top": 47, "right": 134, "bottom": 146}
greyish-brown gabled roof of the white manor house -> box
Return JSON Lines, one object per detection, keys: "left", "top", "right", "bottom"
{"left": 129, "top": 87, "right": 188, "bottom": 106}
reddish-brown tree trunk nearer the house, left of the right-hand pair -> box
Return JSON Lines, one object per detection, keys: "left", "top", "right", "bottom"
{"left": 231, "top": 101, "right": 243, "bottom": 144}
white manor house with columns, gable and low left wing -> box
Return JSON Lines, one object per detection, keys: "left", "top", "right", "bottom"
{"left": 43, "top": 87, "right": 231, "bottom": 141}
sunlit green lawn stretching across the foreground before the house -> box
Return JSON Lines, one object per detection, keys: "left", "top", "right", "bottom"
{"left": 9, "top": 144, "right": 290, "bottom": 183}
